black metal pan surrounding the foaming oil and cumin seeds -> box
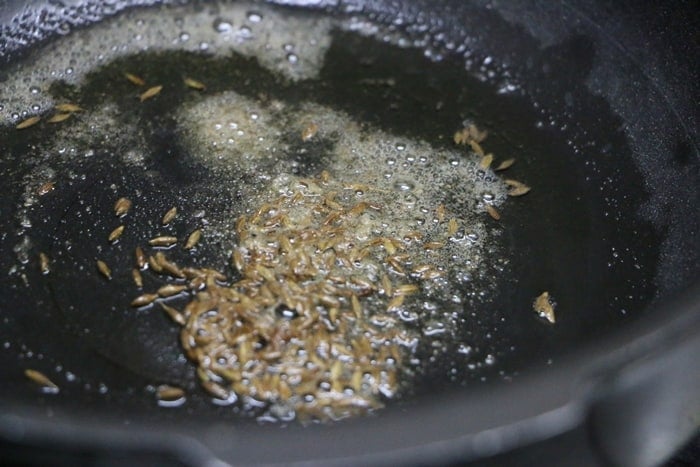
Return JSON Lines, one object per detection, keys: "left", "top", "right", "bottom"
{"left": 0, "top": 1, "right": 700, "bottom": 465}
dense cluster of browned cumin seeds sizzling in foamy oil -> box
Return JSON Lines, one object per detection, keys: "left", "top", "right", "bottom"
{"left": 132, "top": 172, "right": 464, "bottom": 420}
